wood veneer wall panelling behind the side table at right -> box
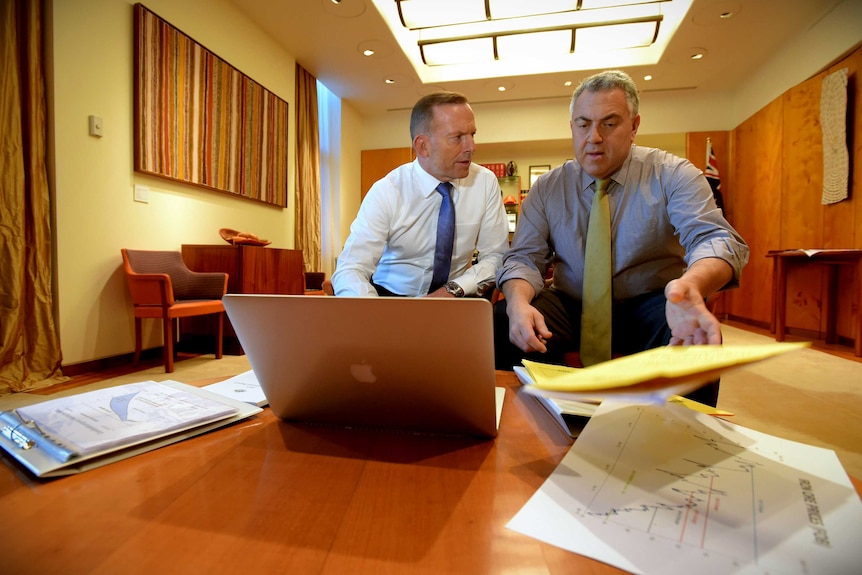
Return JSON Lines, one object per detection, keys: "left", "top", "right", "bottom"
{"left": 687, "top": 48, "right": 862, "bottom": 338}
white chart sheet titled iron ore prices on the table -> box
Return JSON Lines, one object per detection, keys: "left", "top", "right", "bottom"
{"left": 507, "top": 401, "right": 862, "bottom": 575}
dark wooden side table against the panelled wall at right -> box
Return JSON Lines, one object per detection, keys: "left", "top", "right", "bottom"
{"left": 766, "top": 250, "right": 862, "bottom": 356}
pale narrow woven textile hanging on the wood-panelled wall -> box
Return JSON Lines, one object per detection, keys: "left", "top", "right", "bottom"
{"left": 820, "top": 68, "right": 850, "bottom": 205}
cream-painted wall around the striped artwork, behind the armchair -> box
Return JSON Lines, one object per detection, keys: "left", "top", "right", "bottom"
{"left": 48, "top": 0, "right": 295, "bottom": 365}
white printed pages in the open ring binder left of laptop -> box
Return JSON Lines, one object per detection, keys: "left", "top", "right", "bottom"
{"left": 17, "top": 381, "right": 237, "bottom": 456}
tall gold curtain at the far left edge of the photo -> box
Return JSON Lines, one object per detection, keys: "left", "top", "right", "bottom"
{"left": 0, "top": 0, "right": 68, "bottom": 395}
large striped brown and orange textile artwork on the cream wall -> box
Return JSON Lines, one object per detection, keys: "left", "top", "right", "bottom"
{"left": 134, "top": 4, "right": 288, "bottom": 207}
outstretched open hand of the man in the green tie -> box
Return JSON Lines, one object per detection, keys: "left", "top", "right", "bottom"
{"left": 664, "top": 278, "right": 721, "bottom": 345}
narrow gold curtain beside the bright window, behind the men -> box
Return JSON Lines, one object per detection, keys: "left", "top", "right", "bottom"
{"left": 296, "top": 65, "right": 321, "bottom": 272}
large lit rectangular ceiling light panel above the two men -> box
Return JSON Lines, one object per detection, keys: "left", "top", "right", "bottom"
{"left": 370, "top": 0, "right": 694, "bottom": 84}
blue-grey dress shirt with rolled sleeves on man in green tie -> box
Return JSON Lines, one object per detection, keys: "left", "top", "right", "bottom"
{"left": 497, "top": 146, "right": 749, "bottom": 300}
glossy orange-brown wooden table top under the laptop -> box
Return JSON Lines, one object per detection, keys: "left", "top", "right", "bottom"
{"left": 0, "top": 372, "right": 620, "bottom": 575}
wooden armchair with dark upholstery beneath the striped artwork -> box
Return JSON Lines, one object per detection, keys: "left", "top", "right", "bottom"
{"left": 120, "top": 249, "right": 228, "bottom": 373}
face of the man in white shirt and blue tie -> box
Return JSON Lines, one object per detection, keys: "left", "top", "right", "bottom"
{"left": 414, "top": 104, "right": 476, "bottom": 182}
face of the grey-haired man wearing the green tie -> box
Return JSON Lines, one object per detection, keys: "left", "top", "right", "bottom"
{"left": 569, "top": 89, "right": 641, "bottom": 178}
